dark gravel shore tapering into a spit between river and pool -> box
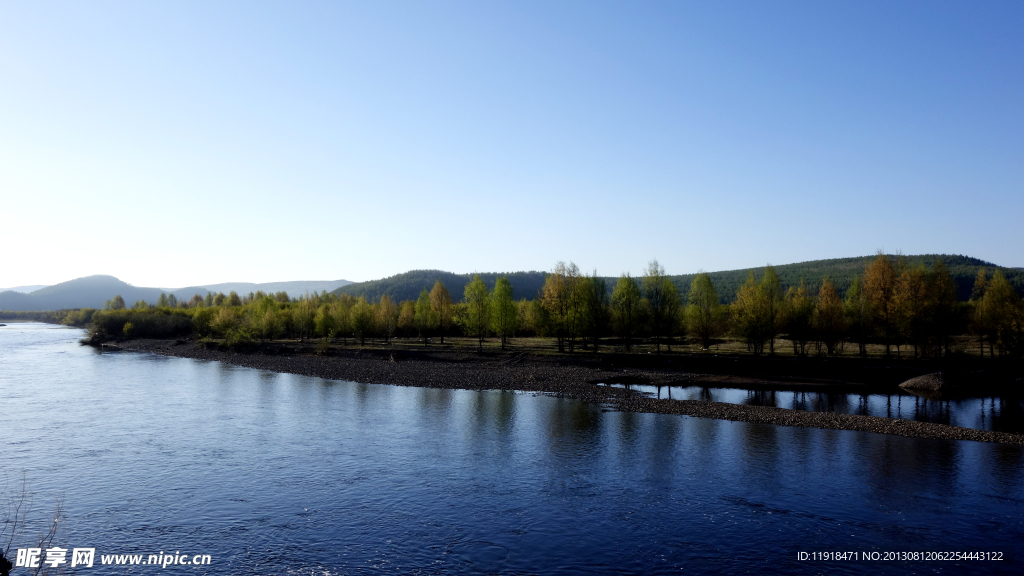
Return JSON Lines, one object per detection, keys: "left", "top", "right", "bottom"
{"left": 119, "top": 339, "right": 1024, "bottom": 445}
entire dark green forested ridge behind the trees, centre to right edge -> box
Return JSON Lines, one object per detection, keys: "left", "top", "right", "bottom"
{"left": 333, "top": 254, "right": 1024, "bottom": 303}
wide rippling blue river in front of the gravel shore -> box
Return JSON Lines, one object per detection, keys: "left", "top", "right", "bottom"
{"left": 0, "top": 324, "right": 1024, "bottom": 575}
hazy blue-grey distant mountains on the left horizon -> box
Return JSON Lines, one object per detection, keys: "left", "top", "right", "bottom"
{"left": 0, "top": 275, "right": 351, "bottom": 311}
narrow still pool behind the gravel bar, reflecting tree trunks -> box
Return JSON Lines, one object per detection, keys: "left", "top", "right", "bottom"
{"left": 608, "top": 384, "right": 1024, "bottom": 434}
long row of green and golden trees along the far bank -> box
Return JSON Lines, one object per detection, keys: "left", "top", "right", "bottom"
{"left": 77, "top": 254, "right": 1024, "bottom": 358}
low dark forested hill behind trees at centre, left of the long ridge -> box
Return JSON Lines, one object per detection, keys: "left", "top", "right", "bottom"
{"left": 332, "top": 270, "right": 546, "bottom": 302}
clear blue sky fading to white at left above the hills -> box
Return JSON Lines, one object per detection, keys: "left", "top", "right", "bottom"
{"left": 0, "top": 0, "right": 1024, "bottom": 287}
